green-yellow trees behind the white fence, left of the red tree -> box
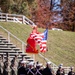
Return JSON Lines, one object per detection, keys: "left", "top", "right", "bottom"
{"left": 0, "top": 0, "right": 36, "bottom": 18}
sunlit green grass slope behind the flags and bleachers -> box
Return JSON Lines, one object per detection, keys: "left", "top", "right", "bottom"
{"left": 0, "top": 22, "right": 75, "bottom": 67}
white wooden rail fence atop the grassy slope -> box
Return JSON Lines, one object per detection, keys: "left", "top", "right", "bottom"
{"left": 0, "top": 13, "right": 35, "bottom": 25}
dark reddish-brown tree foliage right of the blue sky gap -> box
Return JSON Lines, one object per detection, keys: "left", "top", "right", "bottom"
{"left": 61, "top": 0, "right": 75, "bottom": 31}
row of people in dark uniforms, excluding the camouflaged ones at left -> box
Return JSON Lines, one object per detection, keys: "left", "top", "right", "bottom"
{"left": 18, "top": 61, "right": 75, "bottom": 75}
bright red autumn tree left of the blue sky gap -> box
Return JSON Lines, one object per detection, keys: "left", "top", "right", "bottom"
{"left": 33, "top": 0, "right": 51, "bottom": 28}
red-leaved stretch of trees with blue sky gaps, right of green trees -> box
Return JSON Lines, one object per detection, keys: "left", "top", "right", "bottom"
{"left": 35, "top": 0, "right": 75, "bottom": 31}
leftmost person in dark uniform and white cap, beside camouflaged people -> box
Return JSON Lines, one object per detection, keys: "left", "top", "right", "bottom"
{"left": 17, "top": 61, "right": 27, "bottom": 75}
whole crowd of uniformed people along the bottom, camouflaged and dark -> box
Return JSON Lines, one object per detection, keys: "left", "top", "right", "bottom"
{"left": 0, "top": 56, "right": 75, "bottom": 75}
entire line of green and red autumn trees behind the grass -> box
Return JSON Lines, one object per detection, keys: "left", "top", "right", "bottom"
{"left": 0, "top": 0, "right": 75, "bottom": 31}
